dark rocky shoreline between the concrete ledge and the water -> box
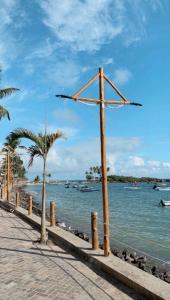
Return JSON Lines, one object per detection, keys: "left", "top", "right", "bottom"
{"left": 11, "top": 185, "right": 170, "bottom": 283}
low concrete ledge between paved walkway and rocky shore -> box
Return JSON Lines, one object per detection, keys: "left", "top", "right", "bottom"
{"left": 0, "top": 202, "right": 170, "bottom": 300}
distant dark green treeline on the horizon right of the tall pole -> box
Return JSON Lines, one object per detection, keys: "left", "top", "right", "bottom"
{"left": 107, "top": 175, "right": 170, "bottom": 182}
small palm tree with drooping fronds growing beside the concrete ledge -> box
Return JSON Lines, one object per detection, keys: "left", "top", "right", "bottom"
{"left": 7, "top": 128, "right": 64, "bottom": 244}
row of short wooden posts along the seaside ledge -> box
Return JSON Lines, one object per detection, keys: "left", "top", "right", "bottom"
{"left": 1, "top": 189, "right": 99, "bottom": 250}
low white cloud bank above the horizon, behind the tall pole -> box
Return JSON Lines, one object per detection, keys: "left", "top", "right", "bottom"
{"left": 19, "top": 134, "right": 170, "bottom": 179}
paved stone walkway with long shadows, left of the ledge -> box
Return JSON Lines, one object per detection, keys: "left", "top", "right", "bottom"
{"left": 0, "top": 209, "right": 143, "bottom": 300}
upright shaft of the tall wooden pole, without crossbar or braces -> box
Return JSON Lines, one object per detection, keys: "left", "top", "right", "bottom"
{"left": 99, "top": 68, "right": 110, "bottom": 256}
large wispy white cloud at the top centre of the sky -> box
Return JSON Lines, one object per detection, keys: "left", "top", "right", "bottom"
{"left": 41, "top": 0, "right": 122, "bottom": 52}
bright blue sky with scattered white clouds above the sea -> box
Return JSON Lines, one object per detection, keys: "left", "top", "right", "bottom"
{"left": 0, "top": 0, "right": 170, "bottom": 179}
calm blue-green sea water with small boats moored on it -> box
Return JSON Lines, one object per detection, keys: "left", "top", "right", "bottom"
{"left": 26, "top": 183, "right": 170, "bottom": 261}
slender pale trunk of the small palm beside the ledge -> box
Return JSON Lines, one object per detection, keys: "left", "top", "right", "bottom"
{"left": 40, "top": 156, "right": 47, "bottom": 244}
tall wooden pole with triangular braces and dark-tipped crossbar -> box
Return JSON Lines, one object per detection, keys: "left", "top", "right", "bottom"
{"left": 56, "top": 68, "right": 142, "bottom": 256}
